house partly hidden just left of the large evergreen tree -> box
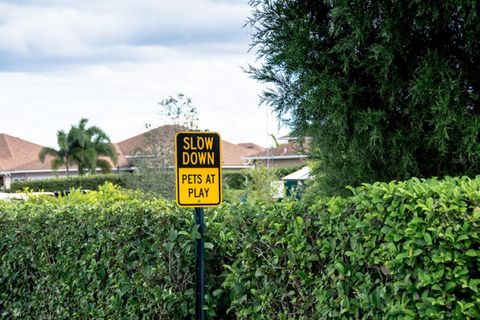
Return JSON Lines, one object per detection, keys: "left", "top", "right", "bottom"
{"left": 242, "top": 140, "right": 307, "bottom": 168}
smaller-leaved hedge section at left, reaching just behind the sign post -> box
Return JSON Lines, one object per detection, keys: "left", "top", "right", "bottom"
{"left": 0, "top": 185, "right": 232, "bottom": 319}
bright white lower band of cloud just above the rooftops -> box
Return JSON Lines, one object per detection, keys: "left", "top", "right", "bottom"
{"left": 0, "top": 52, "right": 284, "bottom": 145}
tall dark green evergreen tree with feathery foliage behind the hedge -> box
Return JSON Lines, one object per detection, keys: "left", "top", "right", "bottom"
{"left": 249, "top": 0, "right": 480, "bottom": 193}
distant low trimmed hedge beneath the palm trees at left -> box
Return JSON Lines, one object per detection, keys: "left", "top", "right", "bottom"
{"left": 10, "top": 173, "right": 125, "bottom": 192}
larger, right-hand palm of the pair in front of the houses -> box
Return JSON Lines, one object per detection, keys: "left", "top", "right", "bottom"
{"left": 68, "top": 118, "right": 117, "bottom": 175}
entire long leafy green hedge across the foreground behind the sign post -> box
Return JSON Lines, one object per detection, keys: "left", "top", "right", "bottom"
{"left": 0, "top": 178, "right": 480, "bottom": 319}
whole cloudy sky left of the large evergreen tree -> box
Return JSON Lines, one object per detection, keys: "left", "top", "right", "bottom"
{"left": 0, "top": 0, "right": 287, "bottom": 147}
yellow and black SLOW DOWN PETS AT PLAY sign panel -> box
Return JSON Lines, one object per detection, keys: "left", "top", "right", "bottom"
{"left": 175, "top": 132, "right": 222, "bottom": 207}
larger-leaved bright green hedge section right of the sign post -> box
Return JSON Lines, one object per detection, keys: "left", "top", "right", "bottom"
{"left": 224, "top": 178, "right": 480, "bottom": 319}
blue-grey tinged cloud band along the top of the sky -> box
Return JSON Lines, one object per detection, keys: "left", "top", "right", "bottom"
{"left": 0, "top": 0, "right": 249, "bottom": 62}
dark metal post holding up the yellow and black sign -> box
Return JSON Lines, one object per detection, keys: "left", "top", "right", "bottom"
{"left": 194, "top": 208, "right": 205, "bottom": 320}
